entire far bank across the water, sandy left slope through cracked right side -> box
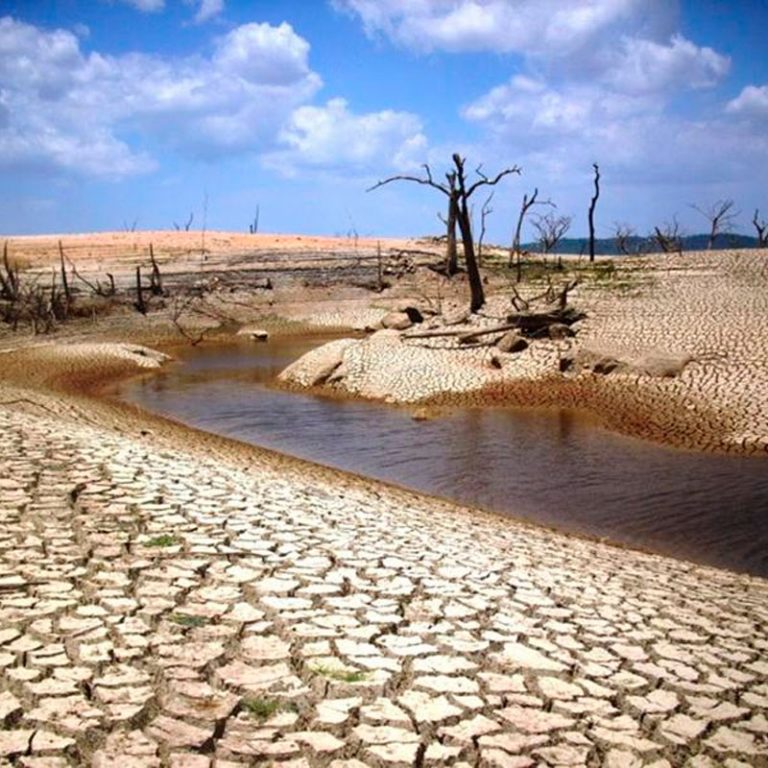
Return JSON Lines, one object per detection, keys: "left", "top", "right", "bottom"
{"left": 6, "top": 232, "right": 768, "bottom": 455}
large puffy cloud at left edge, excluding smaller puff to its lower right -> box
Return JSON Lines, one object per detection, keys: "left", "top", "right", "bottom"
{"left": 0, "top": 18, "right": 322, "bottom": 176}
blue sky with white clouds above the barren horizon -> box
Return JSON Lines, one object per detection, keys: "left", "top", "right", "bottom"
{"left": 0, "top": 0, "right": 768, "bottom": 243}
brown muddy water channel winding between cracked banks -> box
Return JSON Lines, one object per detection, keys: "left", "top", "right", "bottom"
{"left": 120, "top": 339, "right": 768, "bottom": 576}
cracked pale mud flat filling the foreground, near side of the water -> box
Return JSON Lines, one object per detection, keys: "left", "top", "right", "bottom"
{"left": 0, "top": 237, "right": 768, "bottom": 768}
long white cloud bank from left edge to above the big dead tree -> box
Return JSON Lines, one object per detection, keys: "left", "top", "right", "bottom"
{"left": 0, "top": 19, "right": 426, "bottom": 177}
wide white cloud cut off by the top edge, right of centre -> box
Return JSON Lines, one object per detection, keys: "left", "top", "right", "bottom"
{"left": 333, "top": 0, "right": 669, "bottom": 56}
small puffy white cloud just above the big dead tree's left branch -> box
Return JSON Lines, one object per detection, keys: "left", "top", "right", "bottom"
{"left": 268, "top": 99, "right": 427, "bottom": 173}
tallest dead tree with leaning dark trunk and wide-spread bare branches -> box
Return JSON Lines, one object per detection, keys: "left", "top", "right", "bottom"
{"left": 369, "top": 153, "right": 520, "bottom": 312}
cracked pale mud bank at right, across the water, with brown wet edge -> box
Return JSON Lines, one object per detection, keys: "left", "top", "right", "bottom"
{"left": 285, "top": 251, "right": 768, "bottom": 455}
